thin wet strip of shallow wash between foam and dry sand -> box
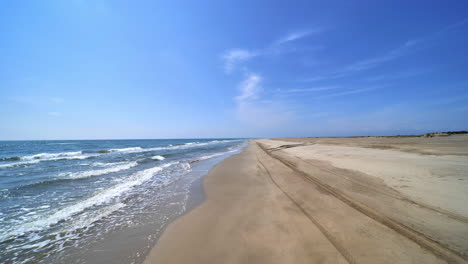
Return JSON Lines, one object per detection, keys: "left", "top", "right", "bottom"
{"left": 69, "top": 143, "right": 249, "bottom": 263}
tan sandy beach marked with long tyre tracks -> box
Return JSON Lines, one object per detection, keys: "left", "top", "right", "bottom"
{"left": 145, "top": 135, "right": 468, "bottom": 264}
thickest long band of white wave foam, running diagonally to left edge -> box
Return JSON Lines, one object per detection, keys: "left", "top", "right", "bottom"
{"left": 0, "top": 162, "right": 177, "bottom": 241}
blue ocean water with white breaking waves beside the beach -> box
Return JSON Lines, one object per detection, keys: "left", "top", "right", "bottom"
{"left": 0, "top": 139, "right": 246, "bottom": 263}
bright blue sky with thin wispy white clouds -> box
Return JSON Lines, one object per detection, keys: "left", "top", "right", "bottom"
{"left": 0, "top": 0, "right": 468, "bottom": 139}
